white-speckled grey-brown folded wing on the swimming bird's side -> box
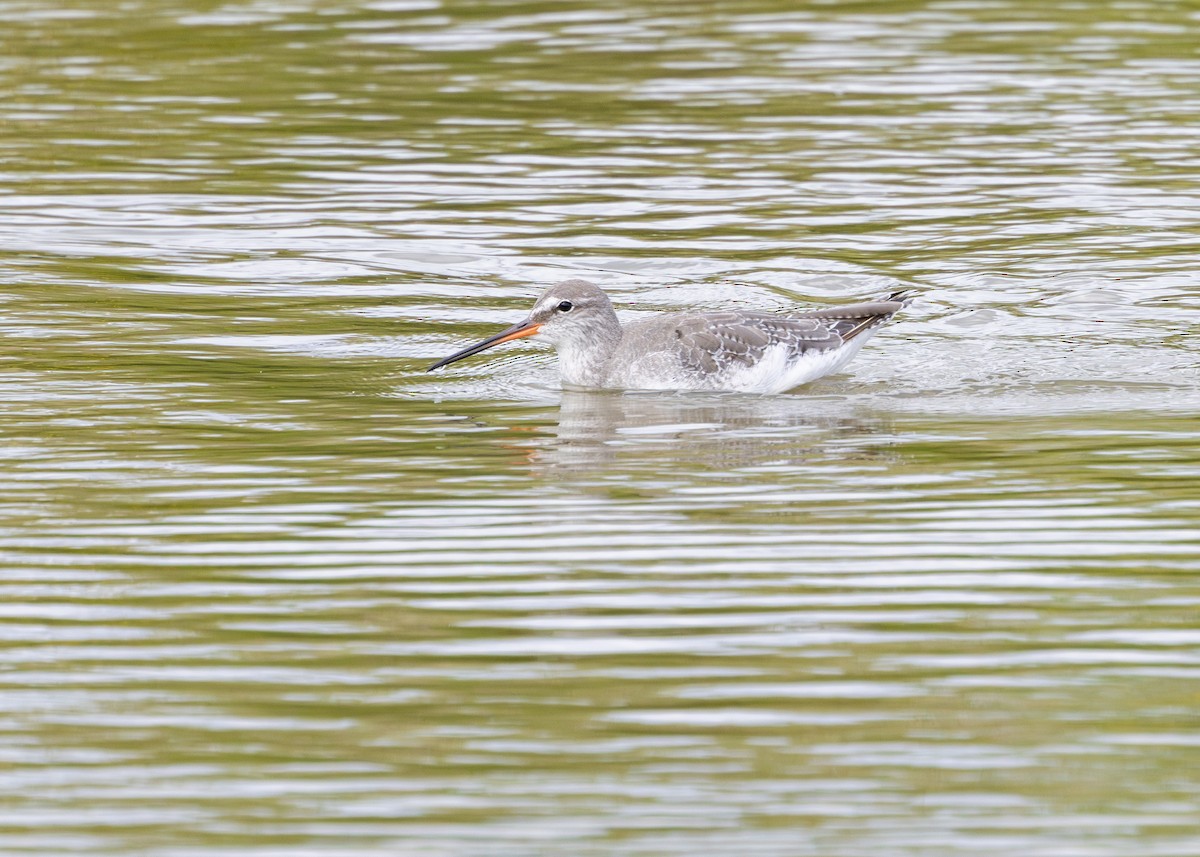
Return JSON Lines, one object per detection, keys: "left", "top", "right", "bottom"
{"left": 674, "top": 310, "right": 842, "bottom": 374}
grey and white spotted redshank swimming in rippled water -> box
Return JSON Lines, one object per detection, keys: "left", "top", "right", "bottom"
{"left": 430, "top": 280, "right": 908, "bottom": 392}
